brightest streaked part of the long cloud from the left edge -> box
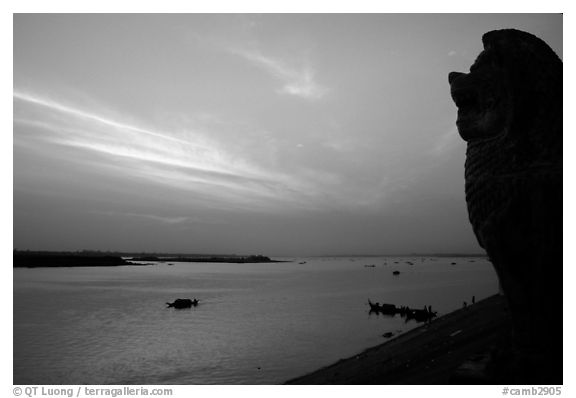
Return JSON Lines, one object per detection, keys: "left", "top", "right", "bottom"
{"left": 14, "top": 90, "right": 324, "bottom": 213}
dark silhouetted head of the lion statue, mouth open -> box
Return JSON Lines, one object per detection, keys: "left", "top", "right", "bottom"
{"left": 448, "top": 29, "right": 562, "bottom": 151}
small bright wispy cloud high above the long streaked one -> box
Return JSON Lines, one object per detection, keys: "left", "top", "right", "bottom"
{"left": 229, "top": 49, "right": 328, "bottom": 100}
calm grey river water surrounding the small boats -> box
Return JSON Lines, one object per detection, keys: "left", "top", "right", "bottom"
{"left": 14, "top": 257, "right": 497, "bottom": 384}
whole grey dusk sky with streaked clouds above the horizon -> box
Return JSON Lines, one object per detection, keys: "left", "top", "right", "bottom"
{"left": 13, "top": 14, "right": 563, "bottom": 256}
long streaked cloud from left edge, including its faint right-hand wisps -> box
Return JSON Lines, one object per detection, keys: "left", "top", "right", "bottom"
{"left": 14, "top": 89, "right": 404, "bottom": 216}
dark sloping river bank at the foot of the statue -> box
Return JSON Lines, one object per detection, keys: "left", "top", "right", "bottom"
{"left": 286, "top": 295, "right": 510, "bottom": 384}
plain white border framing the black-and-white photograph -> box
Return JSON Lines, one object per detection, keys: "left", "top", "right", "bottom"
{"left": 0, "top": 4, "right": 576, "bottom": 398}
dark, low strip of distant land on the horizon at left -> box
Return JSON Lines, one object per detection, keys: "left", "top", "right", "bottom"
{"left": 13, "top": 252, "right": 285, "bottom": 268}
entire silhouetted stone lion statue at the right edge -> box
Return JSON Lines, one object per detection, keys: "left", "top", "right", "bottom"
{"left": 448, "top": 29, "right": 563, "bottom": 384}
